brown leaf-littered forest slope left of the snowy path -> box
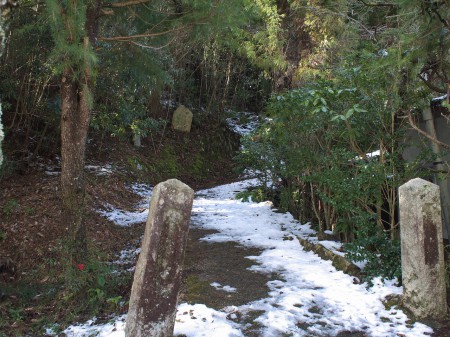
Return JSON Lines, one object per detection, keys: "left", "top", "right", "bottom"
{"left": 0, "top": 120, "right": 239, "bottom": 337}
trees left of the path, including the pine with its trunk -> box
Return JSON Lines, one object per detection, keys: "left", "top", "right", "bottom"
{"left": 1, "top": 0, "right": 284, "bottom": 278}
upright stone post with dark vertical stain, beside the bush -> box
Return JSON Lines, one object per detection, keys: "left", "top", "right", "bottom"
{"left": 399, "top": 178, "right": 447, "bottom": 319}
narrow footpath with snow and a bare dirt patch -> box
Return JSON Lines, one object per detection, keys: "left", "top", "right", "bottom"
{"left": 59, "top": 180, "right": 433, "bottom": 337}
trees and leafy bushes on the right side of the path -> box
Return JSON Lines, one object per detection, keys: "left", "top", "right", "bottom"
{"left": 240, "top": 1, "right": 450, "bottom": 277}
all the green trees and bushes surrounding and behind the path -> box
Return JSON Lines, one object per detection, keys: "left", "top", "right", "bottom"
{"left": 0, "top": 0, "right": 449, "bottom": 284}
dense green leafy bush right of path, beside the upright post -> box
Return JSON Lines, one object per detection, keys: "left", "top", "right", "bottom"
{"left": 238, "top": 69, "right": 428, "bottom": 278}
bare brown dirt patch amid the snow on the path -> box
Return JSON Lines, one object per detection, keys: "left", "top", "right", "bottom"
{"left": 182, "top": 227, "right": 275, "bottom": 310}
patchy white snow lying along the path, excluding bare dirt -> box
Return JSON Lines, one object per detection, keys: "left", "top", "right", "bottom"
{"left": 55, "top": 180, "right": 432, "bottom": 337}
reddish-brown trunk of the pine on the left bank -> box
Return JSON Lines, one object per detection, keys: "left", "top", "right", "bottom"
{"left": 61, "top": 1, "right": 100, "bottom": 264}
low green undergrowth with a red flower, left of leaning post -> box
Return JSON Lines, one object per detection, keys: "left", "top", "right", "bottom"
{"left": 0, "top": 238, "right": 131, "bottom": 337}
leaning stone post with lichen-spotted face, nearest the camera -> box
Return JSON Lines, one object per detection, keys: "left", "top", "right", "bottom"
{"left": 125, "top": 179, "right": 194, "bottom": 337}
